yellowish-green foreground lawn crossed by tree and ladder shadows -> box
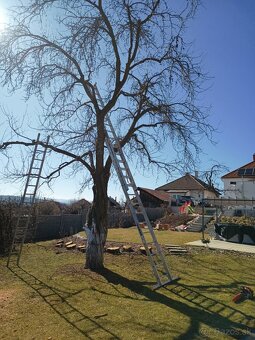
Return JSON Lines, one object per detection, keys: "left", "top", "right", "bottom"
{"left": 0, "top": 234, "right": 255, "bottom": 340}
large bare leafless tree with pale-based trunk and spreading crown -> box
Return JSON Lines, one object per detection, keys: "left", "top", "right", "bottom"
{"left": 0, "top": 0, "right": 212, "bottom": 269}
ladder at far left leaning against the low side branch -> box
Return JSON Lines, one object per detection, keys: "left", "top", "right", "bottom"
{"left": 7, "top": 133, "right": 49, "bottom": 267}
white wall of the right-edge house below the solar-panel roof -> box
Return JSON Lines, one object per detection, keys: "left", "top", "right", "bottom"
{"left": 223, "top": 178, "right": 255, "bottom": 199}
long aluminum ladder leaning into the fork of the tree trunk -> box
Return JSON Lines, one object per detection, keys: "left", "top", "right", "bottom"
{"left": 95, "top": 85, "right": 177, "bottom": 289}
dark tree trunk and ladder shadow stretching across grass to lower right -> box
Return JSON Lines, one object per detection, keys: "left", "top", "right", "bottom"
{"left": 94, "top": 268, "right": 255, "bottom": 339}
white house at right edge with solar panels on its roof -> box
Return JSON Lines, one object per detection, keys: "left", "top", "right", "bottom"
{"left": 221, "top": 154, "right": 255, "bottom": 200}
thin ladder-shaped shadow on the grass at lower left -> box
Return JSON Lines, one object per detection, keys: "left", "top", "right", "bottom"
{"left": 6, "top": 265, "right": 120, "bottom": 339}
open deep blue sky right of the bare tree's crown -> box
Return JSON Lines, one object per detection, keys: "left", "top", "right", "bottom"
{"left": 185, "top": 0, "right": 255, "bottom": 169}
